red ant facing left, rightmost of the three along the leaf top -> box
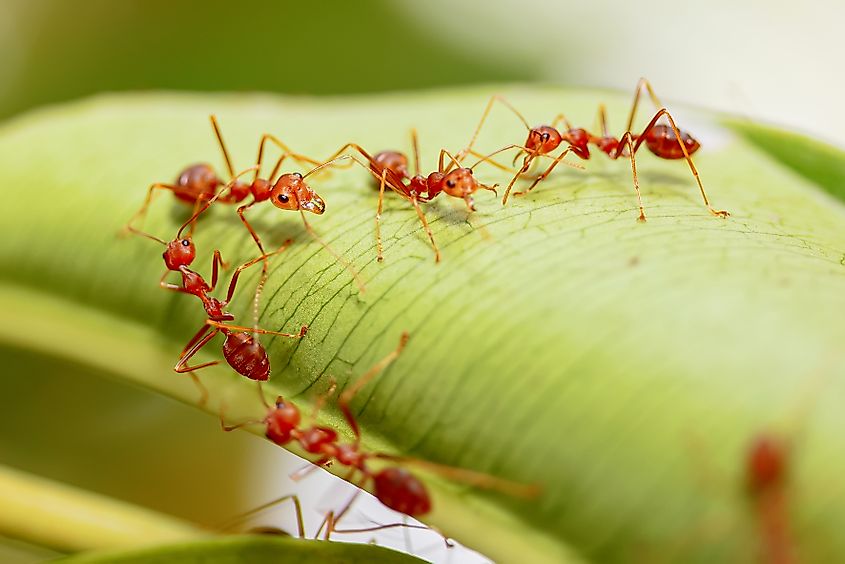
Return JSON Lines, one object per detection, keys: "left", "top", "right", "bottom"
{"left": 457, "top": 78, "right": 730, "bottom": 221}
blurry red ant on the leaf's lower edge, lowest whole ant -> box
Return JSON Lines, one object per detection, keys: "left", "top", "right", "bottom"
{"left": 220, "top": 333, "right": 534, "bottom": 530}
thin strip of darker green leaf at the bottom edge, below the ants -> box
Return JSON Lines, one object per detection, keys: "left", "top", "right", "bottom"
{"left": 56, "top": 536, "right": 422, "bottom": 564}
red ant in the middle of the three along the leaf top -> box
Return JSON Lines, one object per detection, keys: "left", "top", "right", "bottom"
{"left": 332, "top": 133, "right": 501, "bottom": 262}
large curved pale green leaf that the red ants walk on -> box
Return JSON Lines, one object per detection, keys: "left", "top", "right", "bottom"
{"left": 0, "top": 87, "right": 845, "bottom": 562}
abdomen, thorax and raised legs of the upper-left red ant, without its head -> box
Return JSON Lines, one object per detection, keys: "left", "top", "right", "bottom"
{"left": 124, "top": 115, "right": 320, "bottom": 237}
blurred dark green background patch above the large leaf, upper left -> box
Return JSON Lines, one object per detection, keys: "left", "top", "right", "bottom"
{"left": 0, "top": 0, "right": 538, "bottom": 117}
